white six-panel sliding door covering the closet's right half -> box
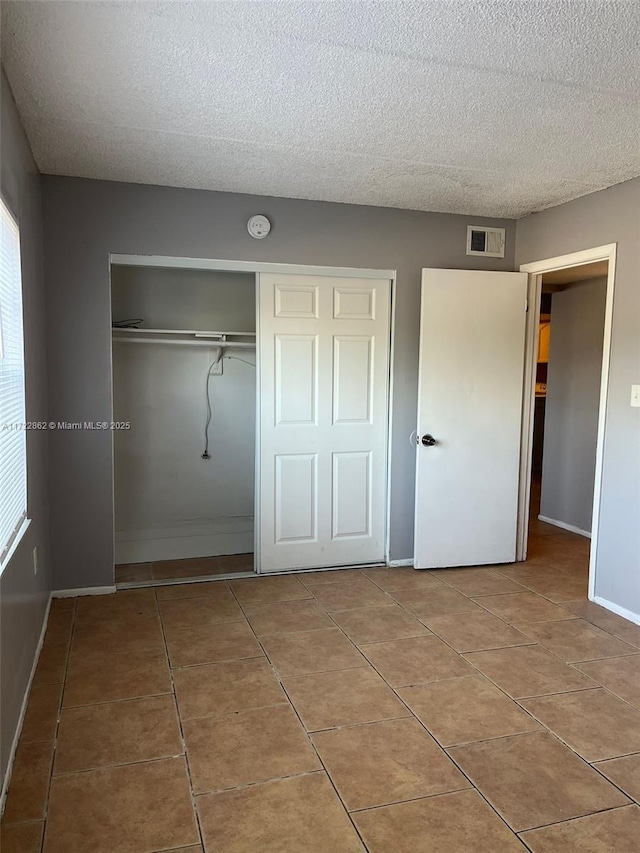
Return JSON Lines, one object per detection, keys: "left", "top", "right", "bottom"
{"left": 258, "top": 274, "right": 390, "bottom": 572}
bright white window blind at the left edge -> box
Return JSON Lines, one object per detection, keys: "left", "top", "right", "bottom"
{"left": 0, "top": 200, "right": 27, "bottom": 564}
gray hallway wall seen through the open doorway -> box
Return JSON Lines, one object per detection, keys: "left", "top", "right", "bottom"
{"left": 540, "top": 278, "right": 607, "bottom": 532}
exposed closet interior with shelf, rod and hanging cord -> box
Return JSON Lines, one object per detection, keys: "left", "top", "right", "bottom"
{"left": 111, "top": 265, "right": 256, "bottom": 586}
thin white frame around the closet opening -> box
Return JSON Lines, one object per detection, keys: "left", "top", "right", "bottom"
{"left": 109, "top": 252, "right": 397, "bottom": 579}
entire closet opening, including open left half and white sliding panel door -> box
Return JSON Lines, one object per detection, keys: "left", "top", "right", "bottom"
{"left": 111, "top": 255, "right": 395, "bottom": 588}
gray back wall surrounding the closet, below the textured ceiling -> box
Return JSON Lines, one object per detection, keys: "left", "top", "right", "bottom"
{"left": 43, "top": 177, "right": 515, "bottom": 589}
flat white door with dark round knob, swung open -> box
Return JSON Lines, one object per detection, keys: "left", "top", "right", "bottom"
{"left": 414, "top": 269, "right": 527, "bottom": 569}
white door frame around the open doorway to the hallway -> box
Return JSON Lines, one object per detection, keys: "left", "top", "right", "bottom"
{"left": 516, "top": 243, "right": 617, "bottom": 600}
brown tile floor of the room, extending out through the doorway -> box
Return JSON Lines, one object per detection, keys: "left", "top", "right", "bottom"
{"left": 2, "top": 522, "right": 640, "bottom": 853}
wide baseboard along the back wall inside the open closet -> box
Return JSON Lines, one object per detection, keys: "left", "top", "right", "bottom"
{"left": 115, "top": 516, "right": 254, "bottom": 565}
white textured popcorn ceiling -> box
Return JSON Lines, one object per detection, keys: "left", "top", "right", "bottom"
{"left": 2, "top": 0, "right": 640, "bottom": 217}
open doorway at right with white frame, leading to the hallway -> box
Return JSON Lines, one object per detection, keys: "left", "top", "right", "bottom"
{"left": 518, "top": 245, "right": 615, "bottom": 599}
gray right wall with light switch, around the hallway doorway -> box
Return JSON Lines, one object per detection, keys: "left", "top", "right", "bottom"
{"left": 516, "top": 178, "right": 640, "bottom": 617}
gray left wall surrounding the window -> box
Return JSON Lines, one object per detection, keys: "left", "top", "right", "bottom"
{"left": 0, "top": 73, "right": 51, "bottom": 779}
